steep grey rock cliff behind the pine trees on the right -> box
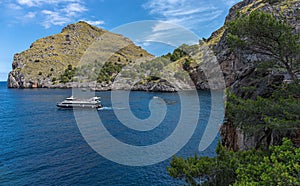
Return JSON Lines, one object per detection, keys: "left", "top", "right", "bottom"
{"left": 209, "top": 0, "right": 300, "bottom": 150}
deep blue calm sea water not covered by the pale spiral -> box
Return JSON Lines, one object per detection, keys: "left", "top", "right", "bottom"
{"left": 0, "top": 82, "right": 217, "bottom": 185}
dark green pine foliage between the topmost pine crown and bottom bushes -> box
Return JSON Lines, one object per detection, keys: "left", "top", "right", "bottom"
{"left": 226, "top": 84, "right": 300, "bottom": 146}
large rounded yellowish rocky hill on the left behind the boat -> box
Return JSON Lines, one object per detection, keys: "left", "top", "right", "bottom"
{"left": 8, "top": 21, "right": 154, "bottom": 88}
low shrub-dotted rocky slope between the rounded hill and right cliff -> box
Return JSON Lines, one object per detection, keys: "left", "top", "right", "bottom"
{"left": 107, "top": 44, "right": 201, "bottom": 91}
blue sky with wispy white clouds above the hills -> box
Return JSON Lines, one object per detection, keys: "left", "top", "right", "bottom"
{"left": 0, "top": 0, "right": 240, "bottom": 81}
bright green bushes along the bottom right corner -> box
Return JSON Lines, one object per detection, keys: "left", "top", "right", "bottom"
{"left": 167, "top": 139, "right": 300, "bottom": 185}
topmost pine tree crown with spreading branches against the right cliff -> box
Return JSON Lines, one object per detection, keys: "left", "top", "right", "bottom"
{"left": 227, "top": 11, "right": 300, "bottom": 81}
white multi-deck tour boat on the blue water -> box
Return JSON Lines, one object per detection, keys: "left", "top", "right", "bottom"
{"left": 56, "top": 96, "right": 102, "bottom": 108}
